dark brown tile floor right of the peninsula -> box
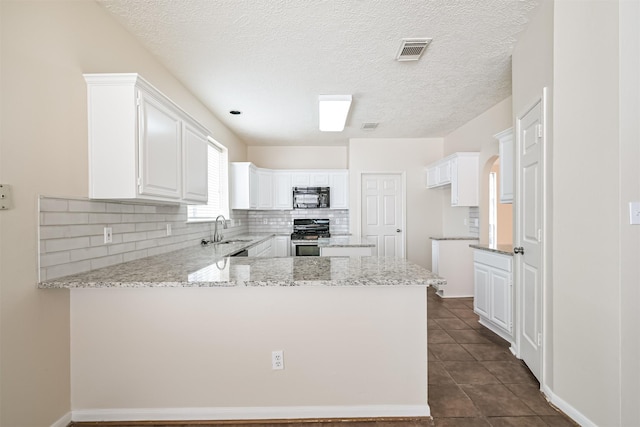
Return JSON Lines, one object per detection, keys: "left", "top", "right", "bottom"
{"left": 427, "top": 288, "right": 576, "bottom": 427}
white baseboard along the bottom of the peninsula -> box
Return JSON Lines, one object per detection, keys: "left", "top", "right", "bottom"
{"left": 72, "top": 404, "right": 431, "bottom": 427}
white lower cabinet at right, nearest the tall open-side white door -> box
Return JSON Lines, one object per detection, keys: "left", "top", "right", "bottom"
{"left": 473, "top": 249, "right": 513, "bottom": 342}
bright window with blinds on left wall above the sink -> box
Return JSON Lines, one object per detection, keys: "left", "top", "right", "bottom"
{"left": 187, "top": 139, "right": 229, "bottom": 221}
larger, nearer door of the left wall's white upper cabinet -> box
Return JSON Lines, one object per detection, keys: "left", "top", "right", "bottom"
{"left": 138, "top": 91, "right": 182, "bottom": 200}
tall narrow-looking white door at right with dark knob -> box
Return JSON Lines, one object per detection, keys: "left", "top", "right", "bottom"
{"left": 514, "top": 100, "right": 544, "bottom": 381}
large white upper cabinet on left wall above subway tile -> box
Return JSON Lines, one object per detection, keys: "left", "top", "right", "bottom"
{"left": 84, "top": 74, "right": 208, "bottom": 203}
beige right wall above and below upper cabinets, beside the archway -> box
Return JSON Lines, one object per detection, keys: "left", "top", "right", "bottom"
{"left": 442, "top": 97, "right": 513, "bottom": 239}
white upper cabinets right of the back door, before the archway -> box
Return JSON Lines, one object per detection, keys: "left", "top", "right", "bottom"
{"left": 427, "top": 152, "right": 480, "bottom": 206}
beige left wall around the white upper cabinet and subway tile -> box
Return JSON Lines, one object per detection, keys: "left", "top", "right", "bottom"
{"left": 0, "top": 0, "right": 246, "bottom": 427}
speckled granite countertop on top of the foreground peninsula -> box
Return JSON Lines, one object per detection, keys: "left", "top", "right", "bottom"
{"left": 39, "top": 235, "right": 446, "bottom": 288}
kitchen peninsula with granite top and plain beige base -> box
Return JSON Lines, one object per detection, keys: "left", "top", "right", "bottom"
{"left": 40, "top": 236, "right": 441, "bottom": 421}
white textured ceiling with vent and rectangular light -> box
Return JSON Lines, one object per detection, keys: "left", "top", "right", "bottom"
{"left": 97, "top": 0, "right": 537, "bottom": 145}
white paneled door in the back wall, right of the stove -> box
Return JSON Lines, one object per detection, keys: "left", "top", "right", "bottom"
{"left": 361, "top": 174, "right": 405, "bottom": 258}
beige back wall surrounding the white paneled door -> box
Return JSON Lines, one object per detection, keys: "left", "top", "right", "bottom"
{"left": 349, "top": 138, "right": 443, "bottom": 269}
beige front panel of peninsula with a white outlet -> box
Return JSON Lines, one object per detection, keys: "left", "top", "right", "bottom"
{"left": 71, "top": 288, "right": 427, "bottom": 419}
